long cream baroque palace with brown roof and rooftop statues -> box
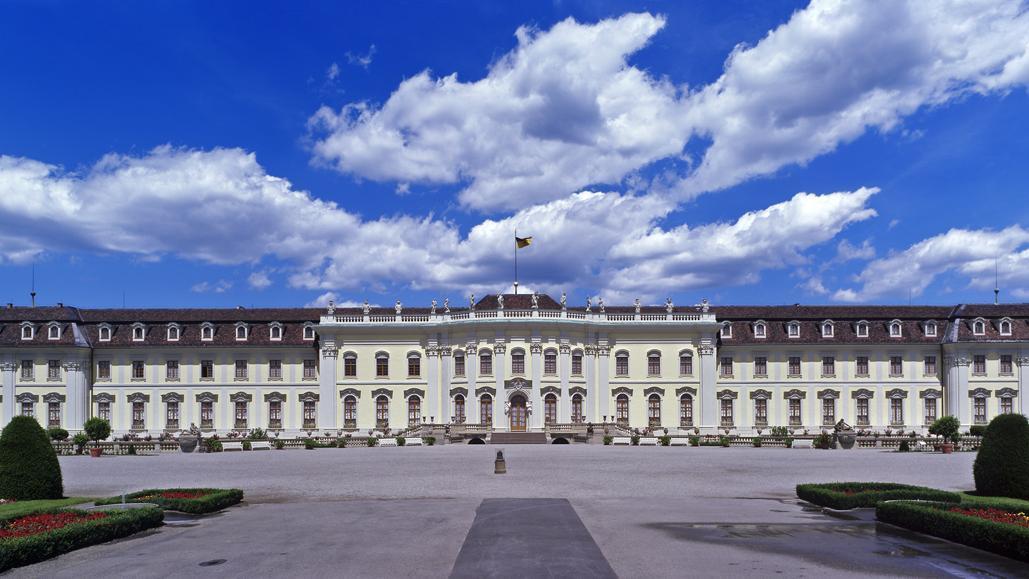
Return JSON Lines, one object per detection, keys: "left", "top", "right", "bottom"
{"left": 0, "top": 294, "right": 1029, "bottom": 435}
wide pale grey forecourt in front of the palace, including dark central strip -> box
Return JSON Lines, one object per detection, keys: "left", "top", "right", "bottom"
{"left": 13, "top": 445, "right": 1023, "bottom": 578}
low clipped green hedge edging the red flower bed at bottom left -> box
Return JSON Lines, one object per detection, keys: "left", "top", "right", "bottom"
{"left": 0, "top": 508, "right": 165, "bottom": 572}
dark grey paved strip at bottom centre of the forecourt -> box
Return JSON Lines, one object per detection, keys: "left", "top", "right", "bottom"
{"left": 451, "top": 499, "right": 616, "bottom": 578}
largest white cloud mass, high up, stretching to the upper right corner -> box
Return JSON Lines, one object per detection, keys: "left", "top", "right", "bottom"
{"left": 310, "top": 0, "right": 1029, "bottom": 211}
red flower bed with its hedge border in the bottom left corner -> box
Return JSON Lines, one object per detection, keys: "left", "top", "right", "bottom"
{"left": 0, "top": 509, "right": 165, "bottom": 572}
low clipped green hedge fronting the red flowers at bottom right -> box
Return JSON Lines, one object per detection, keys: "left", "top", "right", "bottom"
{"left": 876, "top": 502, "right": 1029, "bottom": 562}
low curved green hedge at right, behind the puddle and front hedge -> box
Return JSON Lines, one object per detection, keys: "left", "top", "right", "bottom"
{"left": 796, "top": 482, "right": 961, "bottom": 510}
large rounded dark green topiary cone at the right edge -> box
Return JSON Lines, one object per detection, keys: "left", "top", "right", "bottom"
{"left": 972, "top": 414, "right": 1029, "bottom": 499}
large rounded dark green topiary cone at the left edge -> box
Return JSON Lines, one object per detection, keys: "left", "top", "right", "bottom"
{"left": 0, "top": 417, "right": 64, "bottom": 501}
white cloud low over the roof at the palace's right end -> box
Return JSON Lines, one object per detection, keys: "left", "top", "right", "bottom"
{"left": 833, "top": 225, "right": 1029, "bottom": 301}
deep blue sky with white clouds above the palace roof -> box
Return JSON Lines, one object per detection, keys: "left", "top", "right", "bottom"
{"left": 0, "top": 0, "right": 1029, "bottom": 307}
